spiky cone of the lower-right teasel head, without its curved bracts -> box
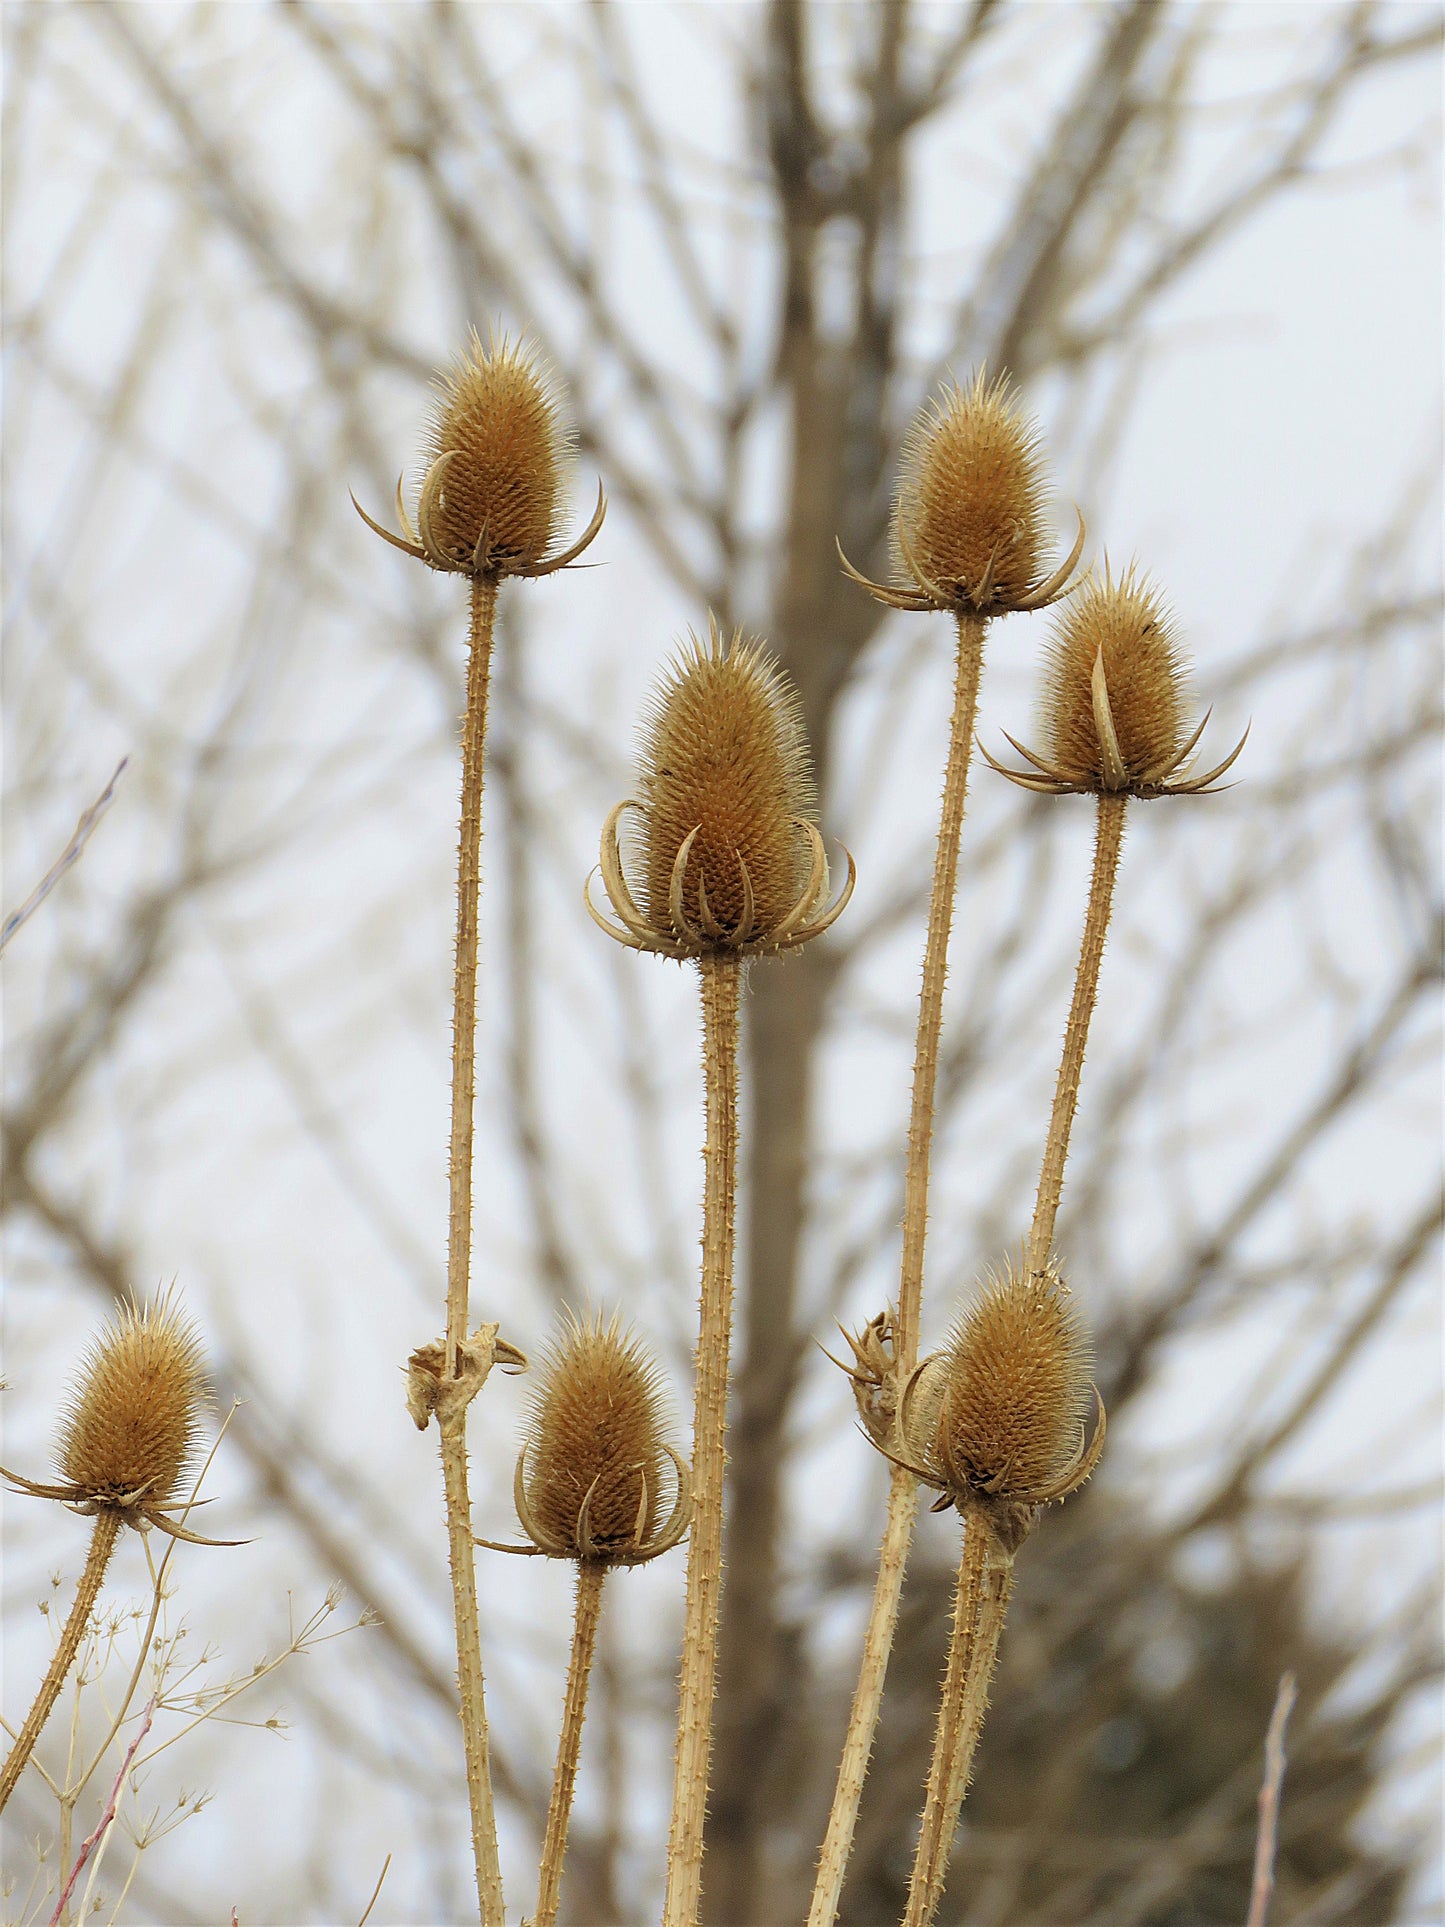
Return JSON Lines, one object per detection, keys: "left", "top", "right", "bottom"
{"left": 934, "top": 1266, "right": 1090, "bottom": 1505}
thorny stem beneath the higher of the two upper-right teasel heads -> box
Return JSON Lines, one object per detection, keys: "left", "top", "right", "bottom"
{"left": 807, "top": 613, "right": 985, "bottom": 1927}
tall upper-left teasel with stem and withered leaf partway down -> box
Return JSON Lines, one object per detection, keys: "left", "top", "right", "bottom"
{"left": 362, "top": 333, "right": 607, "bottom": 1927}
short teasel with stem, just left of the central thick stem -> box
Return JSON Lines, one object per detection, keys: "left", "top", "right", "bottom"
{"left": 478, "top": 1316, "right": 692, "bottom": 1927}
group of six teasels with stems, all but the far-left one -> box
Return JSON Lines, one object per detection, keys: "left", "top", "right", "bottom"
{"left": 360, "top": 337, "right": 1243, "bottom": 1927}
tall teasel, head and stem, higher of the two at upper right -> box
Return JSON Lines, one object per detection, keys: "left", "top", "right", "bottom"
{"left": 807, "top": 372, "right": 1083, "bottom": 1927}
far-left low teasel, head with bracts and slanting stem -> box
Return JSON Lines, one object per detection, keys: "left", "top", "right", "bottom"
{"left": 0, "top": 1295, "right": 225, "bottom": 1811}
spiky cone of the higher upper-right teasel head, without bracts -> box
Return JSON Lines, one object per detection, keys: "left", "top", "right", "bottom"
{"left": 894, "top": 370, "right": 1048, "bottom": 611}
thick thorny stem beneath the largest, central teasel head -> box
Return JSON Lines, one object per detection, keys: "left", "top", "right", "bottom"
{"left": 663, "top": 958, "right": 740, "bottom": 1927}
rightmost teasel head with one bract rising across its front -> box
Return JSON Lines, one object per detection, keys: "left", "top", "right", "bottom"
{"left": 985, "top": 557, "right": 1248, "bottom": 796}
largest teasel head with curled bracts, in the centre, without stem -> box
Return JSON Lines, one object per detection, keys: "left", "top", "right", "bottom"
{"left": 588, "top": 622, "right": 854, "bottom": 958}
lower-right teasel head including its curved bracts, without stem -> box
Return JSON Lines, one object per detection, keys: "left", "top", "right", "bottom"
{"left": 898, "top": 1264, "right": 1104, "bottom": 1515}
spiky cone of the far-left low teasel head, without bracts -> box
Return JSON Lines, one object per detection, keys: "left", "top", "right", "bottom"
{"left": 60, "top": 1297, "right": 208, "bottom": 1507}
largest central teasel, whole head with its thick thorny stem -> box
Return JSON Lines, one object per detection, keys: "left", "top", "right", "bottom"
{"left": 586, "top": 622, "right": 855, "bottom": 1927}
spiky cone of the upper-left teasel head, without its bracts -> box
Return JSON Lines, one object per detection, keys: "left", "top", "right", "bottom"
{"left": 426, "top": 330, "right": 572, "bottom": 574}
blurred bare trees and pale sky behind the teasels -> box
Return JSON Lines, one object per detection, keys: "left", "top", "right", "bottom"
{"left": 0, "top": 0, "right": 1441, "bottom": 1927}
